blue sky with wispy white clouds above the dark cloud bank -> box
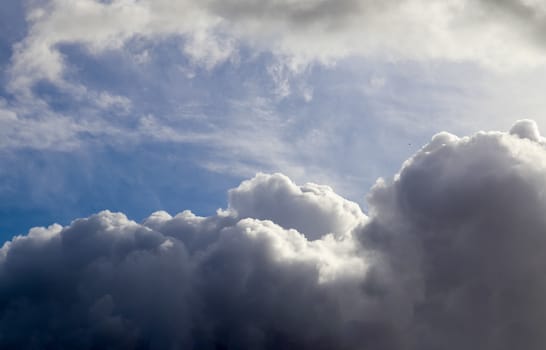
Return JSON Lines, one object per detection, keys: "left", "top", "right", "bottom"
{"left": 5, "top": 0, "right": 546, "bottom": 238}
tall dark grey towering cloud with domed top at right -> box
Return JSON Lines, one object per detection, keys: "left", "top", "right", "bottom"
{"left": 363, "top": 120, "right": 546, "bottom": 349}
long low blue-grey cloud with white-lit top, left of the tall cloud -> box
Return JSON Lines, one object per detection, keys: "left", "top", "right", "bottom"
{"left": 0, "top": 175, "right": 371, "bottom": 349}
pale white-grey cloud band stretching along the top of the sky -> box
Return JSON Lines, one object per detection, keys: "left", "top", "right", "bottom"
{"left": 10, "top": 0, "right": 546, "bottom": 92}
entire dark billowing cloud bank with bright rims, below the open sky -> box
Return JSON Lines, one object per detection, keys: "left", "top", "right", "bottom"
{"left": 0, "top": 120, "right": 546, "bottom": 350}
